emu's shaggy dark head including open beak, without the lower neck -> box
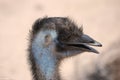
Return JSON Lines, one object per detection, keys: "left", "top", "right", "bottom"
{"left": 31, "top": 17, "right": 102, "bottom": 59}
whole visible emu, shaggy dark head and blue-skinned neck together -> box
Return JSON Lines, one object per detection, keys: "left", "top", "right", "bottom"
{"left": 29, "top": 17, "right": 102, "bottom": 80}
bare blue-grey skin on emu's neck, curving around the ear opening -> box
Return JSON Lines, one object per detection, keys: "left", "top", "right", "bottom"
{"left": 32, "top": 30, "right": 57, "bottom": 80}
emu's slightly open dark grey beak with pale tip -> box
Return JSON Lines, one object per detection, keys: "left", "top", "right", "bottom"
{"left": 62, "top": 35, "right": 102, "bottom": 53}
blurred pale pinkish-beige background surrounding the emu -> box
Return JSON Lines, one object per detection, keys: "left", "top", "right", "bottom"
{"left": 0, "top": 0, "right": 120, "bottom": 80}
